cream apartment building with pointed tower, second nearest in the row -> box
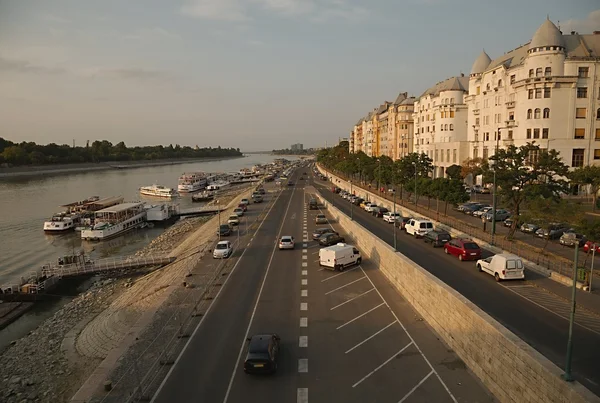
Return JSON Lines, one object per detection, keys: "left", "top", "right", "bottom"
{"left": 412, "top": 74, "right": 469, "bottom": 178}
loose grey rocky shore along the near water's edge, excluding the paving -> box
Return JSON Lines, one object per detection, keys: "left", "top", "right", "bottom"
{"left": 0, "top": 187, "right": 248, "bottom": 403}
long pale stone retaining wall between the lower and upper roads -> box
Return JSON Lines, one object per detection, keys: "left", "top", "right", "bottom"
{"left": 319, "top": 178, "right": 600, "bottom": 403}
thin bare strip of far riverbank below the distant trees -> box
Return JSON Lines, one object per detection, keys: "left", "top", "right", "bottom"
{"left": 0, "top": 156, "right": 244, "bottom": 180}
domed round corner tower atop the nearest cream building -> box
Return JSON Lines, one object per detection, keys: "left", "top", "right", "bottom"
{"left": 525, "top": 19, "right": 565, "bottom": 77}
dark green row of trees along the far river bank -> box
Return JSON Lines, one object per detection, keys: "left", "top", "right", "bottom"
{"left": 0, "top": 137, "right": 242, "bottom": 166}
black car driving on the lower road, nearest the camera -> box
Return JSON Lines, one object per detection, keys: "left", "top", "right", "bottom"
{"left": 244, "top": 334, "right": 280, "bottom": 374}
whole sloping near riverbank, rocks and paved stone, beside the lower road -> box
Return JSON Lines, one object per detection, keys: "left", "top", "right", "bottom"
{"left": 0, "top": 187, "right": 250, "bottom": 403}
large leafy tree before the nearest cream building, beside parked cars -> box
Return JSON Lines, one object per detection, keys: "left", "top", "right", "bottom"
{"left": 482, "top": 143, "right": 568, "bottom": 237}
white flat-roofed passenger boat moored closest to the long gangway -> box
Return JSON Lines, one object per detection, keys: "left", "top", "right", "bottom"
{"left": 81, "top": 202, "right": 146, "bottom": 241}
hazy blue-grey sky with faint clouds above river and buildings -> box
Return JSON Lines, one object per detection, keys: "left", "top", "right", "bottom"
{"left": 0, "top": 0, "right": 600, "bottom": 151}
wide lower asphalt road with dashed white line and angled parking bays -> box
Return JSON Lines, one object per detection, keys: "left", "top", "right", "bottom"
{"left": 153, "top": 168, "right": 494, "bottom": 403}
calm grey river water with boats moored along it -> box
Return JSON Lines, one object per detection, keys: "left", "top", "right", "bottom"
{"left": 0, "top": 154, "right": 293, "bottom": 285}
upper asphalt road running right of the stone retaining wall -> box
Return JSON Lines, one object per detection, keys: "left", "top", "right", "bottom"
{"left": 315, "top": 174, "right": 600, "bottom": 394}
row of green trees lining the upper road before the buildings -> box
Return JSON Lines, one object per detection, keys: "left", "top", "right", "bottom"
{"left": 317, "top": 142, "right": 600, "bottom": 243}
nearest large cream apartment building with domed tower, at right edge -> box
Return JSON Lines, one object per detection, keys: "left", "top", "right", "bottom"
{"left": 466, "top": 19, "right": 600, "bottom": 167}
